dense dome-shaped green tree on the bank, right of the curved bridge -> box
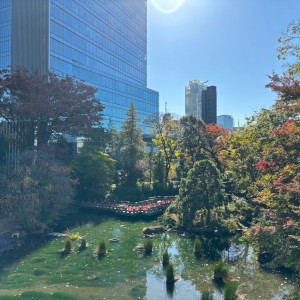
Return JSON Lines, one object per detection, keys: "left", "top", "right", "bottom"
{"left": 178, "top": 160, "right": 224, "bottom": 228}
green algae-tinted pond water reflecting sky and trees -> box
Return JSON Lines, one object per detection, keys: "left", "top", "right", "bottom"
{"left": 0, "top": 214, "right": 297, "bottom": 300}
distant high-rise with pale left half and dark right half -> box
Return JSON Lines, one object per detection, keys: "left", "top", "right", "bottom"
{"left": 185, "top": 80, "right": 217, "bottom": 124}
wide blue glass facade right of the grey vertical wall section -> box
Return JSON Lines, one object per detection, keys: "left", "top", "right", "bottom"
{"left": 50, "top": 0, "right": 159, "bottom": 130}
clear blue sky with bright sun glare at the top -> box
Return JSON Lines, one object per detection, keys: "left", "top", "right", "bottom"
{"left": 148, "top": 0, "right": 300, "bottom": 126}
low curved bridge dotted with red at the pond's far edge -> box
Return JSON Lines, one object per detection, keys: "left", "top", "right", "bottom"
{"left": 80, "top": 196, "right": 176, "bottom": 217}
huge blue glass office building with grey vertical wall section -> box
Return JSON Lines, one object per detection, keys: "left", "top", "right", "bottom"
{"left": 0, "top": 0, "right": 159, "bottom": 129}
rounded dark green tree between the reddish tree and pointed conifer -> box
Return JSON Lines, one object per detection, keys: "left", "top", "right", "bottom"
{"left": 72, "top": 145, "right": 115, "bottom": 200}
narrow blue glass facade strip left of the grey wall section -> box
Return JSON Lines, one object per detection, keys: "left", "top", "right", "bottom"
{"left": 0, "top": 0, "right": 12, "bottom": 68}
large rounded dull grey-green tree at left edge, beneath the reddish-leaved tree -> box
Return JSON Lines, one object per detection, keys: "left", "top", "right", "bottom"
{"left": 0, "top": 151, "right": 73, "bottom": 229}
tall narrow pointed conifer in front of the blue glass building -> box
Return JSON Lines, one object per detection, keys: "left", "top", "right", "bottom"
{"left": 121, "top": 101, "right": 145, "bottom": 186}
